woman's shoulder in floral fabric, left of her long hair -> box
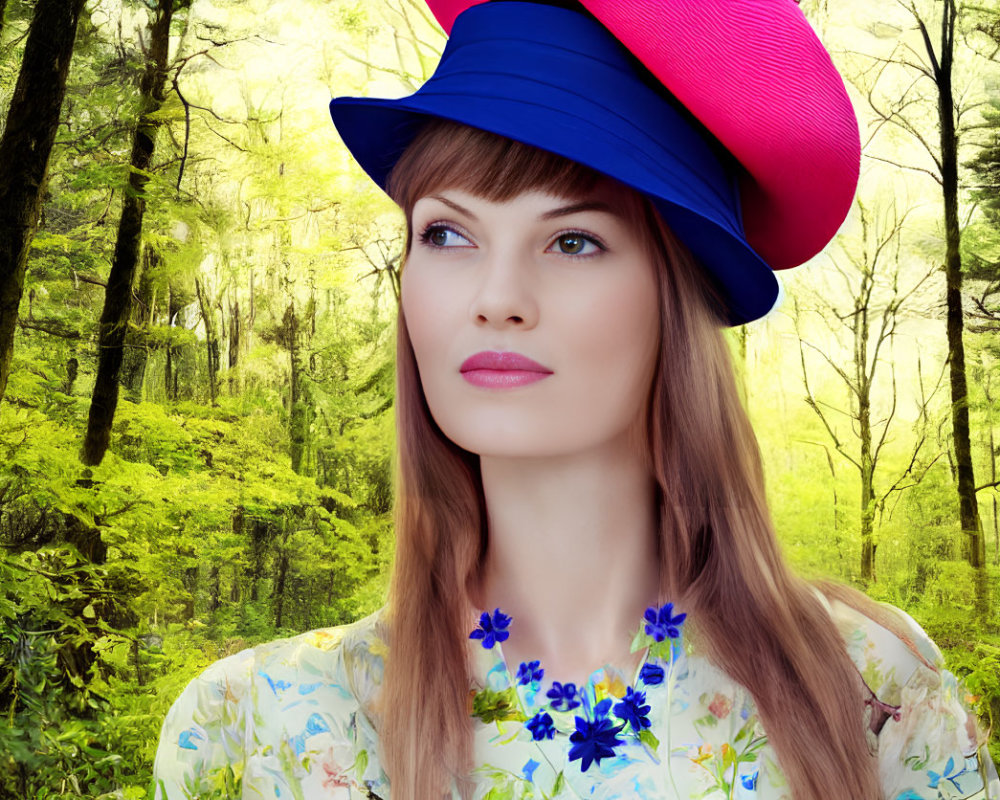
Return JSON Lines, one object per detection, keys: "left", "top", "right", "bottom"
{"left": 153, "top": 611, "right": 385, "bottom": 800}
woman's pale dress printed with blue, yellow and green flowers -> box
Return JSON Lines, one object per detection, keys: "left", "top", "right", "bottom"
{"left": 152, "top": 601, "right": 1000, "bottom": 800}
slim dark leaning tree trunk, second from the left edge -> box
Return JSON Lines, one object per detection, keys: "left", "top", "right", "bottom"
{"left": 81, "top": 0, "right": 174, "bottom": 466}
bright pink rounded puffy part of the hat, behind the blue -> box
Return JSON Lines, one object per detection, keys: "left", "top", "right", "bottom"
{"left": 428, "top": 0, "right": 861, "bottom": 269}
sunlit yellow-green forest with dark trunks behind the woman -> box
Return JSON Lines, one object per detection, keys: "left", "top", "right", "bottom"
{"left": 0, "top": 0, "right": 1000, "bottom": 798}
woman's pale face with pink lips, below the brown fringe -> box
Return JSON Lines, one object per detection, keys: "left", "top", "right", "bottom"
{"left": 402, "top": 181, "right": 659, "bottom": 457}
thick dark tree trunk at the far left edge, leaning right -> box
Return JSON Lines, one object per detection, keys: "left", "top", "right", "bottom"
{"left": 0, "top": 0, "right": 84, "bottom": 401}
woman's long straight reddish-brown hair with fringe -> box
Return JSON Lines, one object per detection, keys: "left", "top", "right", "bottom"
{"left": 378, "top": 120, "right": 880, "bottom": 800}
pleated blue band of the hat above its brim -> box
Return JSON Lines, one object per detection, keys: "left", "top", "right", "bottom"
{"left": 422, "top": 2, "right": 742, "bottom": 230}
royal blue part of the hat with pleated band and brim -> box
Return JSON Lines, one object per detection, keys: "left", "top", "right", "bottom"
{"left": 330, "top": 2, "right": 779, "bottom": 325}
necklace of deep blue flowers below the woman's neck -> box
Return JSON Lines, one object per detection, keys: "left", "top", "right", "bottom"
{"left": 469, "top": 603, "right": 687, "bottom": 772}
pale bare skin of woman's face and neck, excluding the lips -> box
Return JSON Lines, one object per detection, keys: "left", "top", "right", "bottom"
{"left": 402, "top": 180, "right": 659, "bottom": 684}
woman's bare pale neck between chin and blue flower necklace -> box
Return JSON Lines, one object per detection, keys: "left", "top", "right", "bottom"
{"left": 472, "top": 438, "right": 659, "bottom": 681}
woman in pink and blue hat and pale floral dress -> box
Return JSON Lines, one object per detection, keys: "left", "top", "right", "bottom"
{"left": 154, "top": 0, "right": 995, "bottom": 800}
